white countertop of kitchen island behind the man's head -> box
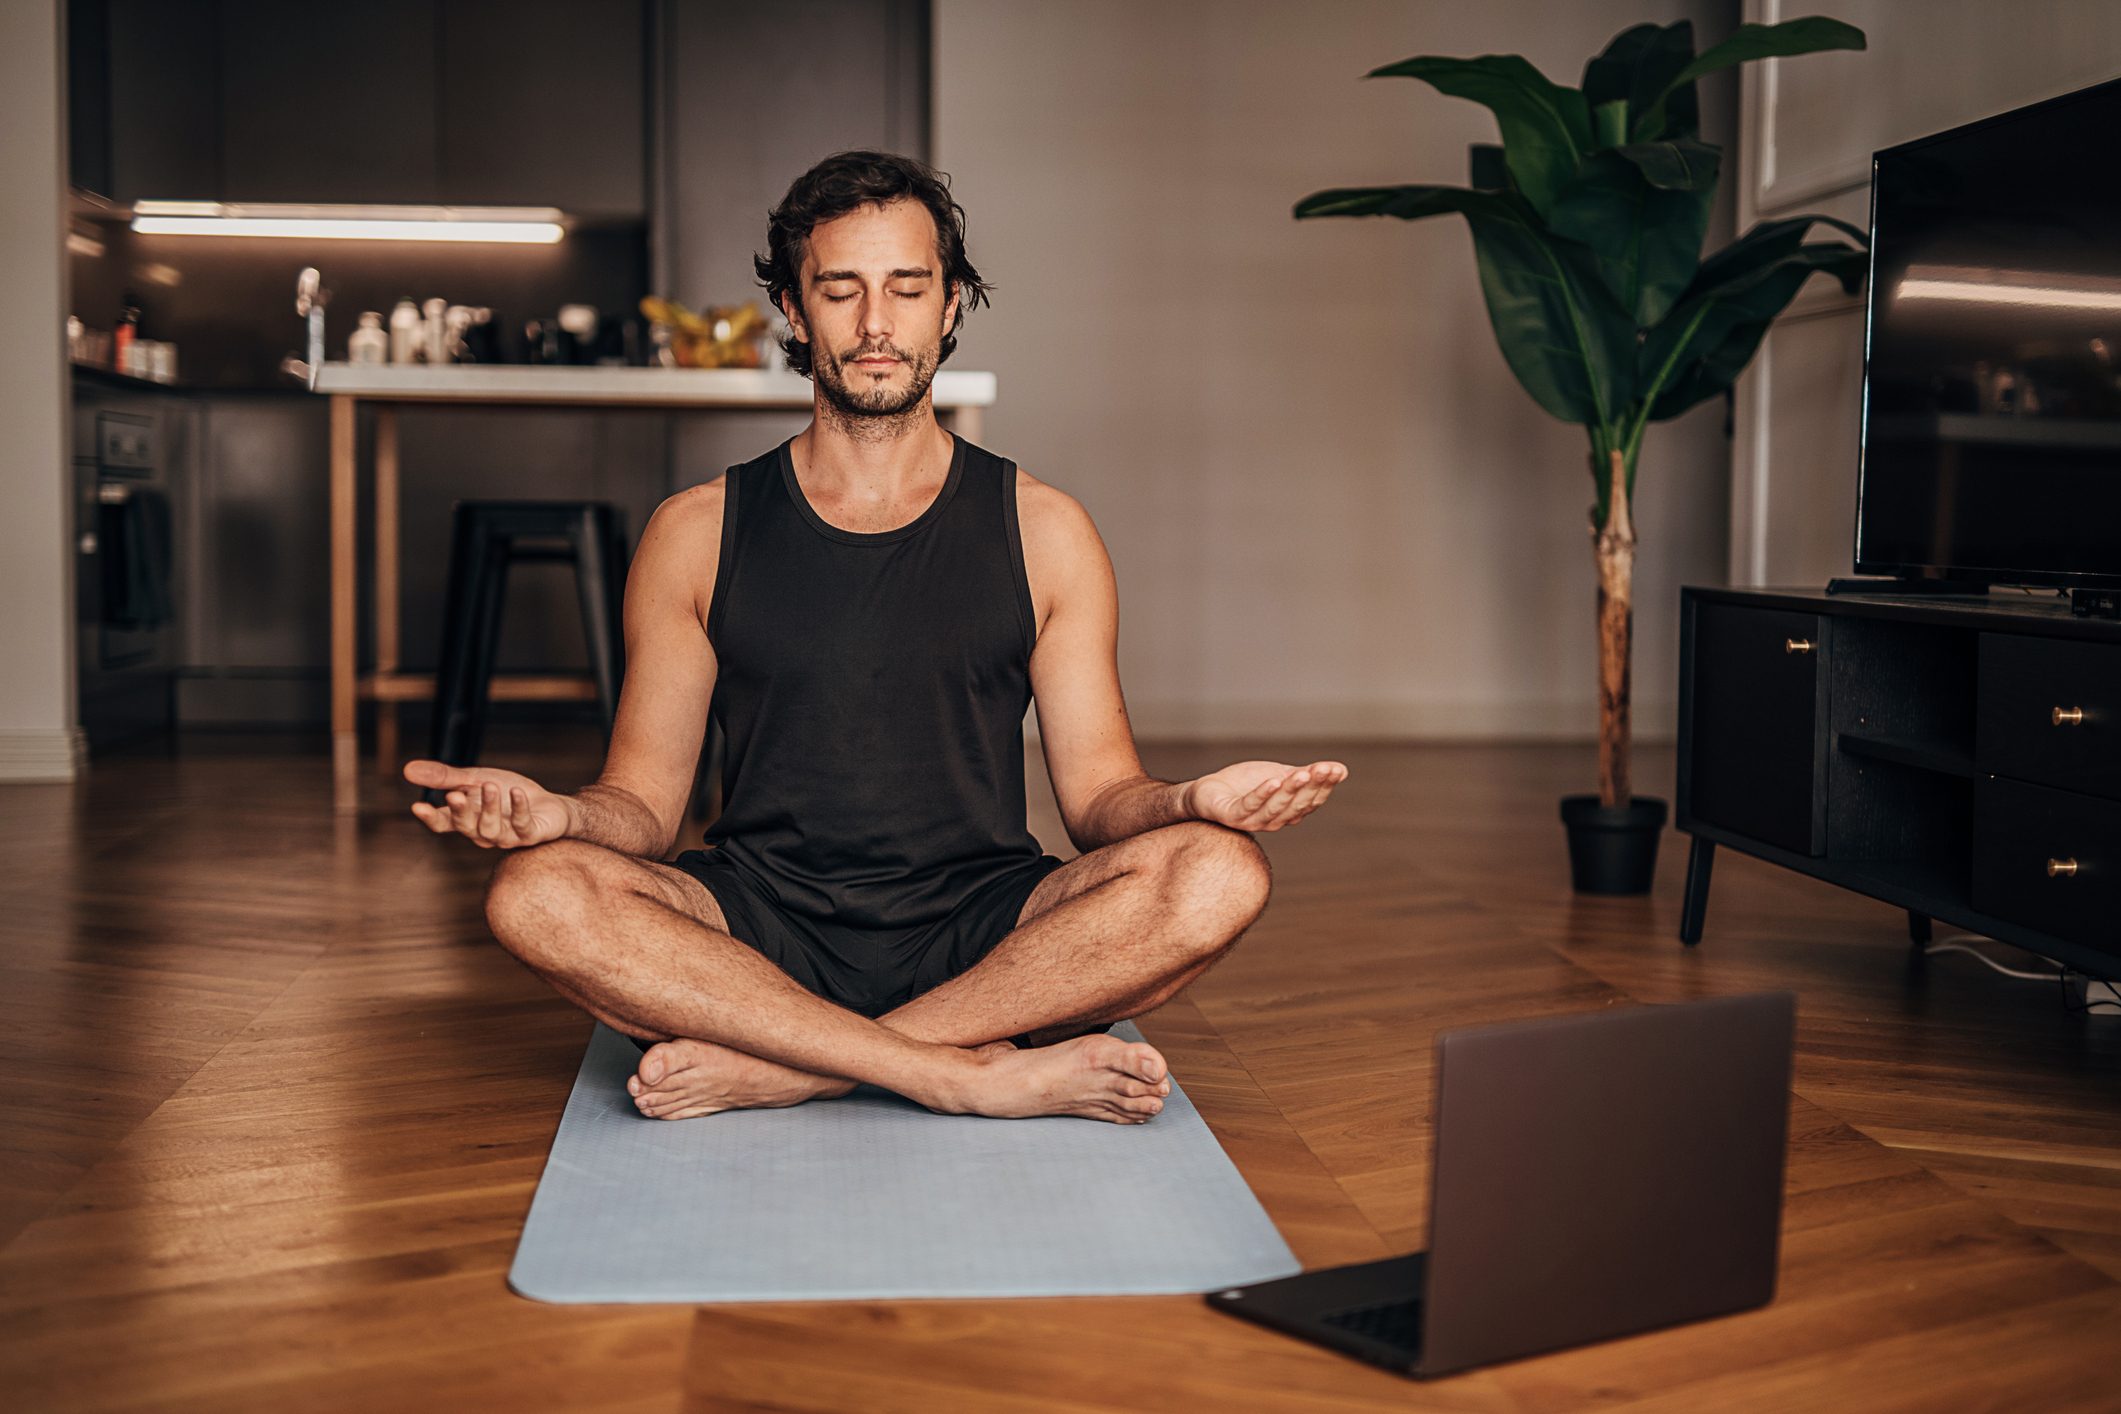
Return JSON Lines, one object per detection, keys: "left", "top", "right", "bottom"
{"left": 316, "top": 363, "right": 995, "bottom": 409}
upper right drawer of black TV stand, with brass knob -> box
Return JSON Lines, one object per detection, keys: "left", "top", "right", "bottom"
{"left": 1975, "top": 634, "right": 2121, "bottom": 799}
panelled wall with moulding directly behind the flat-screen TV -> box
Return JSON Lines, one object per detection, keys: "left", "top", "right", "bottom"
{"left": 1731, "top": 0, "right": 2121, "bottom": 585}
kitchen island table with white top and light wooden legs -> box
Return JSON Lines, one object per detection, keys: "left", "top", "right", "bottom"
{"left": 314, "top": 363, "right": 995, "bottom": 810}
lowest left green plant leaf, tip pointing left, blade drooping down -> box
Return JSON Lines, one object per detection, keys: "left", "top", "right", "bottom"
{"left": 1296, "top": 187, "right": 1635, "bottom": 424}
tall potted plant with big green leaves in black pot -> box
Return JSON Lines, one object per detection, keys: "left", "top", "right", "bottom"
{"left": 1296, "top": 15, "right": 1869, "bottom": 892}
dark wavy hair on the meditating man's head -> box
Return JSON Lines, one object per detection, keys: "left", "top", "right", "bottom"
{"left": 751, "top": 148, "right": 993, "bottom": 377}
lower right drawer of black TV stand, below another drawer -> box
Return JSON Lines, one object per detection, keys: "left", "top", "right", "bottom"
{"left": 1970, "top": 776, "right": 2121, "bottom": 952}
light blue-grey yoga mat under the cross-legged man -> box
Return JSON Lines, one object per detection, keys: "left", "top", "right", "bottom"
{"left": 509, "top": 1022, "right": 1302, "bottom": 1302}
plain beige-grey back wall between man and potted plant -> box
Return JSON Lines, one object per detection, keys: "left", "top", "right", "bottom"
{"left": 933, "top": 0, "right": 1737, "bottom": 740}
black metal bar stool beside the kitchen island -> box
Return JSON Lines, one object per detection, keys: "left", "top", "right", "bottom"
{"left": 424, "top": 500, "right": 628, "bottom": 806}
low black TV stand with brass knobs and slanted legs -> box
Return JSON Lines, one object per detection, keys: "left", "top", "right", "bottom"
{"left": 1676, "top": 587, "right": 2121, "bottom": 977}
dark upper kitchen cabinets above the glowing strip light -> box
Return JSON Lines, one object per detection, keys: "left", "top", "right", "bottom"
{"left": 68, "top": 0, "right": 649, "bottom": 220}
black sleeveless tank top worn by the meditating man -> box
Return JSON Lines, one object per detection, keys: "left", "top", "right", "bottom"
{"left": 706, "top": 435, "right": 1041, "bottom": 929}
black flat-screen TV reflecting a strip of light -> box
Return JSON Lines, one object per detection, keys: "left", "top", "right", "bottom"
{"left": 1856, "top": 78, "right": 2121, "bottom": 589}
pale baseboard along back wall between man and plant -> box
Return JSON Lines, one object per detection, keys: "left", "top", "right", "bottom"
{"left": 1024, "top": 697, "right": 1680, "bottom": 744}
